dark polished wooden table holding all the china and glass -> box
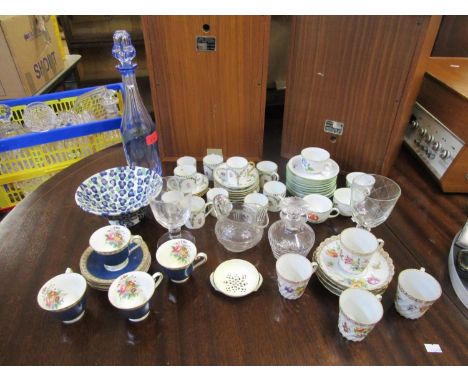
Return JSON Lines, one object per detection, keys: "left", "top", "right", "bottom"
{"left": 0, "top": 147, "right": 468, "bottom": 365}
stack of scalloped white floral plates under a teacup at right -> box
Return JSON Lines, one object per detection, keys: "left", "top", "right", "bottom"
{"left": 314, "top": 236, "right": 395, "bottom": 296}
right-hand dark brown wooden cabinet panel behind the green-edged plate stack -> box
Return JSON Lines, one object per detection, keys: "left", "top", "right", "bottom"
{"left": 281, "top": 16, "right": 440, "bottom": 173}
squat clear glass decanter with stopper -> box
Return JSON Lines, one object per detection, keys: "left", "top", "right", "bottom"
{"left": 268, "top": 196, "right": 315, "bottom": 258}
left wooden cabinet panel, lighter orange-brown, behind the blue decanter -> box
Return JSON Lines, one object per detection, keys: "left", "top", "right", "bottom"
{"left": 142, "top": 16, "right": 270, "bottom": 161}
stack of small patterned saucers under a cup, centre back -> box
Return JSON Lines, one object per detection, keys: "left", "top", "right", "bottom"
{"left": 213, "top": 163, "right": 260, "bottom": 202}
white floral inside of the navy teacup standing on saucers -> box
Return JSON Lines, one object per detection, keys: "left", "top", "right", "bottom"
{"left": 89, "top": 225, "right": 132, "bottom": 254}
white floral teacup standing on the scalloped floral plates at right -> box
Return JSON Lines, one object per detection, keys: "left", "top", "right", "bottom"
{"left": 338, "top": 227, "right": 384, "bottom": 275}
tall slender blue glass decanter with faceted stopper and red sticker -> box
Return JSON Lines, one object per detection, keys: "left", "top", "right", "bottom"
{"left": 112, "top": 30, "right": 162, "bottom": 175}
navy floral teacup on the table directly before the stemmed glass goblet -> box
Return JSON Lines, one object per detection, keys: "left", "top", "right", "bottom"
{"left": 156, "top": 239, "right": 208, "bottom": 283}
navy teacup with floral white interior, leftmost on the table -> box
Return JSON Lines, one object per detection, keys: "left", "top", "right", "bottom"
{"left": 37, "top": 268, "right": 86, "bottom": 324}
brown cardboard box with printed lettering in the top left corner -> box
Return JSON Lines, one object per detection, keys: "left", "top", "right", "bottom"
{"left": 0, "top": 16, "right": 64, "bottom": 99}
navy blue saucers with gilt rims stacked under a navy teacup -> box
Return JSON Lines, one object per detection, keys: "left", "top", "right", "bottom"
{"left": 80, "top": 241, "right": 151, "bottom": 291}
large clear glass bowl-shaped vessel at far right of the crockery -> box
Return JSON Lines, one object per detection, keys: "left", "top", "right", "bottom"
{"left": 351, "top": 174, "right": 401, "bottom": 231}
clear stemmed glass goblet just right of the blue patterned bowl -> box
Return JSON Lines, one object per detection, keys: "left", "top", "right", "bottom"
{"left": 150, "top": 176, "right": 196, "bottom": 247}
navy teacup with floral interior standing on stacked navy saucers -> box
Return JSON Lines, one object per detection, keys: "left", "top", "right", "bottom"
{"left": 89, "top": 225, "right": 143, "bottom": 272}
